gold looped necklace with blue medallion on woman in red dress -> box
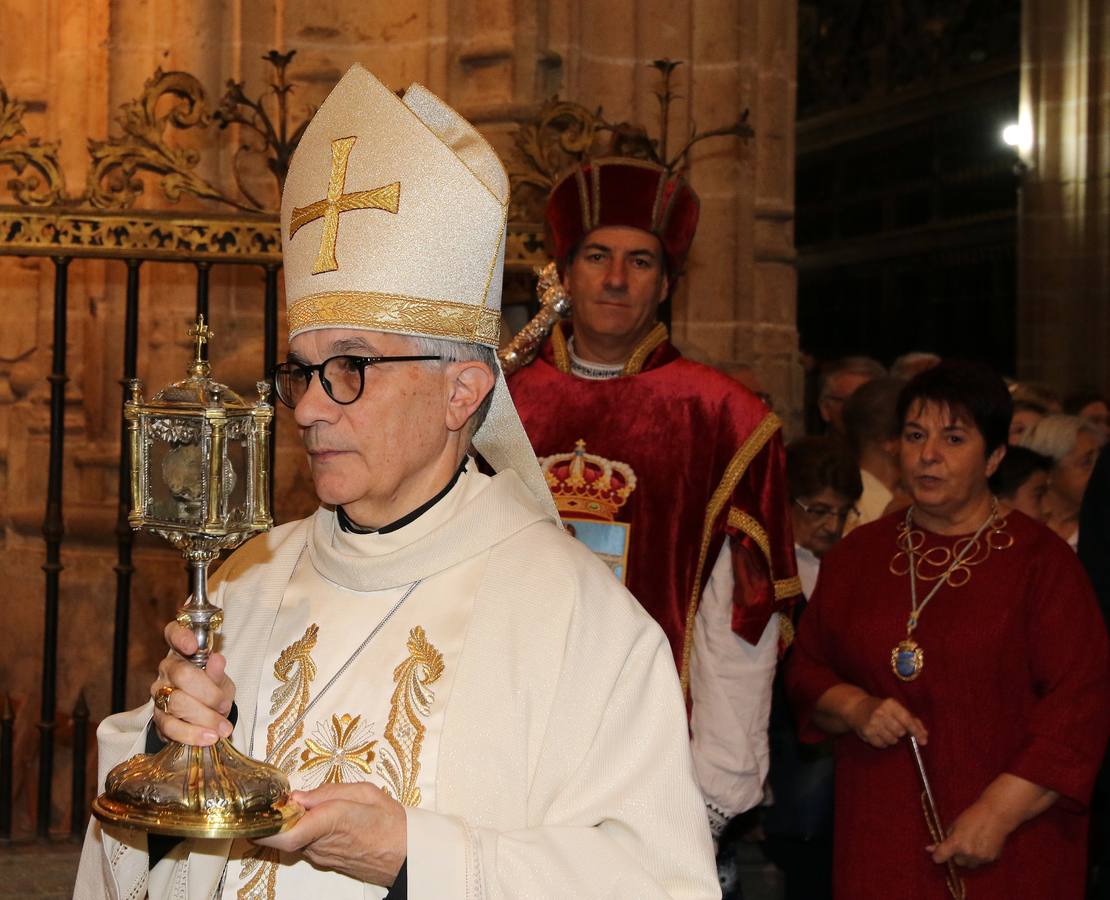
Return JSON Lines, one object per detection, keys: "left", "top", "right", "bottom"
{"left": 890, "top": 497, "right": 1013, "bottom": 681}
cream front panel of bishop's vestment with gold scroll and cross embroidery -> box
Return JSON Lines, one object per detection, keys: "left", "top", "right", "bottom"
{"left": 227, "top": 548, "right": 475, "bottom": 900}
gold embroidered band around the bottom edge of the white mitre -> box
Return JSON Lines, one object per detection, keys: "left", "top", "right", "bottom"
{"left": 289, "top": 291, "right": 501, "bottom": 347}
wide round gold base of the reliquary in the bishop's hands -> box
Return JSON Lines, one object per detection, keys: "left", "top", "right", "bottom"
{"left": 92, "top": 739, "right": 304, "bottom": 838}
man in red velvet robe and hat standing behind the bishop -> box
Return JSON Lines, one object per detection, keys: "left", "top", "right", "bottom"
{"left": 509, "top": 159, "right": 800, "bottom": 835}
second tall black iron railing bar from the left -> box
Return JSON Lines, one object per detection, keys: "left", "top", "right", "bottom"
{"left": 112, "top": 260, "right": 142, "bottom": 712}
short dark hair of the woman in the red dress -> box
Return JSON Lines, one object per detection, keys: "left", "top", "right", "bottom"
{"left": 898, "top": 360, "right": 1013, "bottom": 456}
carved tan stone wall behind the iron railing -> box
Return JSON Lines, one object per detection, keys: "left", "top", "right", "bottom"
{"left": 0, "top": 0, "right": 801, "bottom": 835}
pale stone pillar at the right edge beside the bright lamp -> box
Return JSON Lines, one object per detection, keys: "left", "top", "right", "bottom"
{"left": 1018, "top": 0, "right": 1110, "bottom": 392}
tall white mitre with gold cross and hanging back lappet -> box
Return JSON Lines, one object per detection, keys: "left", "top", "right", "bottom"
{"left": 281, "top": 65, "right": 558, "bottom": 522}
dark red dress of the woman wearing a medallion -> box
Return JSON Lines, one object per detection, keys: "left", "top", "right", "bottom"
{"left": 787, "top": 512, "right": 1110, "bottom": 900}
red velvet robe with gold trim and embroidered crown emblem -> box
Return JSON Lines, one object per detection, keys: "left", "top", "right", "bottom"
{"left": 508, "top": 323, "right": 800, "bottom": 690}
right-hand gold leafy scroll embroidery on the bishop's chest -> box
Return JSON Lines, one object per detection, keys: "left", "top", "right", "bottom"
{"left": 377, "top": 625, "right": 444, "bottom": 807}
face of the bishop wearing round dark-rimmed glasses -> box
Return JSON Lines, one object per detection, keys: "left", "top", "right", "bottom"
{"left": 290, "top": 328, "right": 447, "bottom": 526}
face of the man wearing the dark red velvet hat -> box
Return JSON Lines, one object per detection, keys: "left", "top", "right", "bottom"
{"left": 564, "top": 225, "right": 667, "bottom": 353}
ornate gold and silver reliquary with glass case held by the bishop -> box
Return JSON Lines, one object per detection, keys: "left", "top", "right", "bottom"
{"left": 92, "top": 316, "right": 303, "bottom": 838}
